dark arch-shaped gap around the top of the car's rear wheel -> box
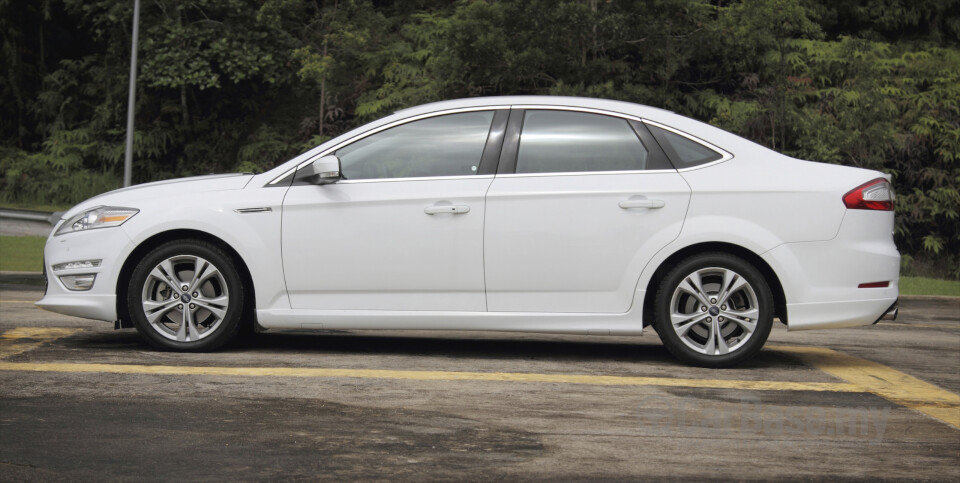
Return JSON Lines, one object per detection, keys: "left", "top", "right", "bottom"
{"left": 643, "top": 242, "right": 787, "bottom": 327}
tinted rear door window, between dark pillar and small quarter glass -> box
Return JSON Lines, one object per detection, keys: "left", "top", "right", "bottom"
{"left": 517, "top": 110, "right": 647, "bottom": 173}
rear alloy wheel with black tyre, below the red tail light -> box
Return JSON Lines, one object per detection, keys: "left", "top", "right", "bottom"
{"left": 654, "top": 253, "right": 773, "bottom": 367}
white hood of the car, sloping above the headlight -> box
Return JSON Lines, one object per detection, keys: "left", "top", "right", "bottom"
{"left": 61, "top": 173, "right": 253, "bottom": 218}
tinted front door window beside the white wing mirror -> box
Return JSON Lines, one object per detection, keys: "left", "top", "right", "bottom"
{"left": 336, "top": 111, "right": 493, "bottom": 179}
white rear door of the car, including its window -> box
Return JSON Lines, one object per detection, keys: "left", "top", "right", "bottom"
{"left": 483, "top": 107, "right": 690, "bottom": 313}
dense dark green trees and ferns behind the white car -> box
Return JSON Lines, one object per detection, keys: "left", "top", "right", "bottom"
{"left": 0, "top": 0, "right": 960, "bottom": 277}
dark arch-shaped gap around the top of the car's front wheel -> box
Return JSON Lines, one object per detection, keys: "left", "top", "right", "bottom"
{"left": 116, "top": 229, "right": 256, "bottom": 328}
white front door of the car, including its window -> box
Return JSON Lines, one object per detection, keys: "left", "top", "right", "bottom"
{"left": 282, "top": 111, "right": 505, "bottom": 311}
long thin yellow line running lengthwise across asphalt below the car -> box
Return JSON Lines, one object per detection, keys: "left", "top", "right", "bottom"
{"left": 0, "top": 362, "right": 863, "bottom": 392}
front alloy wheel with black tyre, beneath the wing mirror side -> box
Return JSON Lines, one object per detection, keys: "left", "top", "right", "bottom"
{"left": 127, "top": 240, "right": 243, "bottom": 351}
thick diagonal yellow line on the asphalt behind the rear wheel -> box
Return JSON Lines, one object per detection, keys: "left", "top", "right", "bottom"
{"left": 771, "top": 346, "right": 960, "bottom": 429}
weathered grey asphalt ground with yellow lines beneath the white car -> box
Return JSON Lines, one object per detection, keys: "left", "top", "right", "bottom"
{"left": 0, "top": 285, "right": 960, "bottom": 481}
